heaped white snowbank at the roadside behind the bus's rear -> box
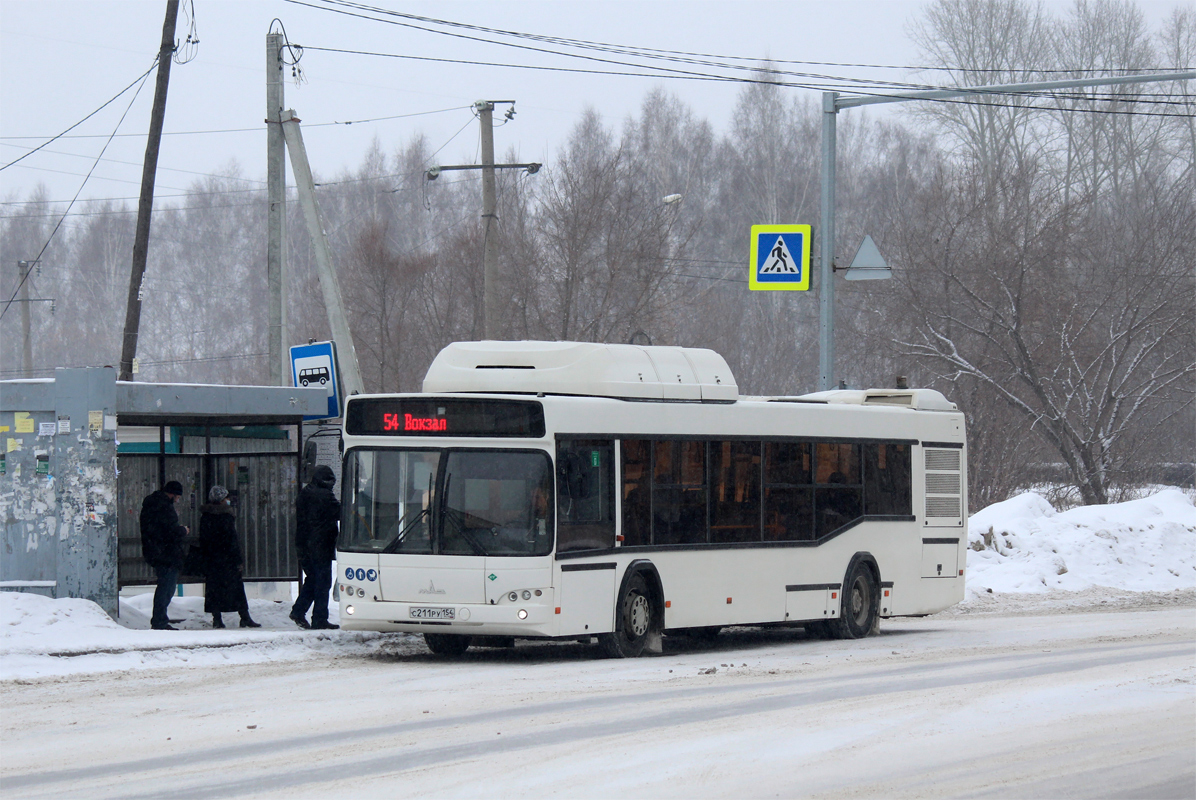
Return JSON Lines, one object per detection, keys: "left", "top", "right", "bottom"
{"left": 966, "top": 489, "right": 1196, "bottom": 599}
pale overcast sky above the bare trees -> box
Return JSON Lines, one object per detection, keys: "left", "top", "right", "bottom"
{"left": 0, "top": 0, "right": 1176, "bottom": 201}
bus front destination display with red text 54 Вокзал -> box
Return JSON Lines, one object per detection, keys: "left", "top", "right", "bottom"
{"left": 344, "top": 397, "right": 544, "bottom": 439}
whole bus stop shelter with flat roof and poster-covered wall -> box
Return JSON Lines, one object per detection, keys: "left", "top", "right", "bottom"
{"left": 0, "top": 367, "right": 328, "bottom": 616}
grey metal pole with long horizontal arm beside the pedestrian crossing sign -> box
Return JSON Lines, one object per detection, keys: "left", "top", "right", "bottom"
{"left": 818, "top": 71, "right": 1196, "bottom": 391}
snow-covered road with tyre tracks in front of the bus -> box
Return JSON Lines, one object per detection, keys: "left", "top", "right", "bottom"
{"left": 0, "top": 602, "right": 1196, "bottom": 798}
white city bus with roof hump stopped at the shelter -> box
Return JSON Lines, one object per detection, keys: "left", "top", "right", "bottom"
{"left": 337, "top": 342, "right": 968, "bottom": 657}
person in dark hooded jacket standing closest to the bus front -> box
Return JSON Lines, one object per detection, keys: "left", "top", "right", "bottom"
{"left": 291, "top": 464, "right": 341, "bottom": 629}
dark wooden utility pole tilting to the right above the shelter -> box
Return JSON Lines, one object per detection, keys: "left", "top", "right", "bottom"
{"left": 120, "top": 0, "right": 178, "bottom": 380}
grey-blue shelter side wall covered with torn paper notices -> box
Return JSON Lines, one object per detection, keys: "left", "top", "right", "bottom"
{"left": 0, "top": 367, "right": 117, "bottom": 616}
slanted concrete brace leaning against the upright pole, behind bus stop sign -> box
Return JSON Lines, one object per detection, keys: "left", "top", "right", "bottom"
{"left": 281, "top": 109, "right": 365, "bottom": 396}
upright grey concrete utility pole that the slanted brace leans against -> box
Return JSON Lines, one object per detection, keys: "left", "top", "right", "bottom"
{"left": 266, "top": 33, "right": 291, "bottom": 386}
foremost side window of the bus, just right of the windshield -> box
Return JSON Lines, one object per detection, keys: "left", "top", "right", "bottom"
{"left": 556, "top": 439, "right": 615, "bottom": 552}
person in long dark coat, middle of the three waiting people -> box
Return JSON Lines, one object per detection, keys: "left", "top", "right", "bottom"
{"left": 200, "top": 486, "right": 261, "bottom": 628}
